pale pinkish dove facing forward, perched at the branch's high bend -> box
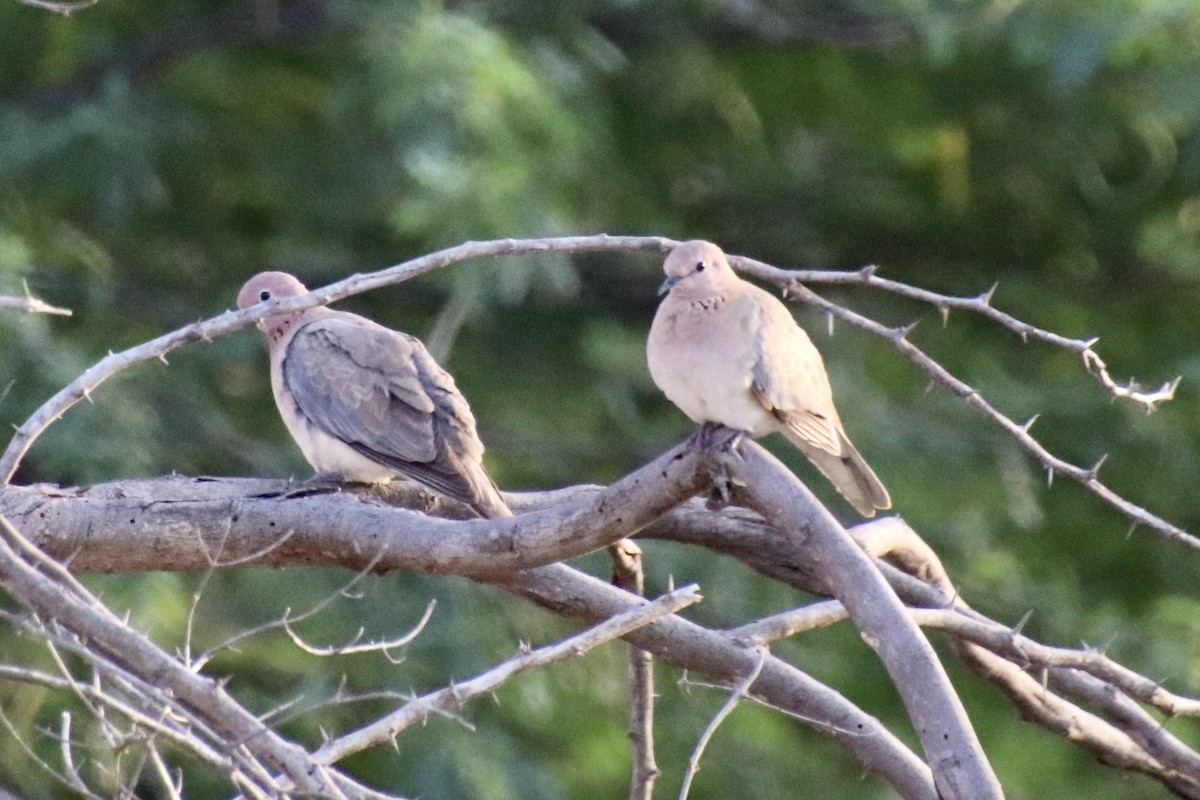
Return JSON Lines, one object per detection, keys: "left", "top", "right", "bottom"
{"left": 646, "top": 241, "right": 892, "bottom": 517}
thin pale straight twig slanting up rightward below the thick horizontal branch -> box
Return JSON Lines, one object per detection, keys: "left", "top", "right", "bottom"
{"left": 313, "top": 584, "right": 701, "bottom": 764}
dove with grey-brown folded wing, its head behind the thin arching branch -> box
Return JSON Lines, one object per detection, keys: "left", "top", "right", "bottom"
{"left": 238, "top": 272, "right": 512, "bottom": 518}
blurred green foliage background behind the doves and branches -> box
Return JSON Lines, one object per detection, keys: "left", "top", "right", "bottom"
{"left": 0, "top": 0, "right": 1200, "bottom": 800}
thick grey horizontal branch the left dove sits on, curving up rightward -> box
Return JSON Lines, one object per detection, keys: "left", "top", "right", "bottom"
{"left": 0, "top": 447, "right": 707, "bottom": 577}
